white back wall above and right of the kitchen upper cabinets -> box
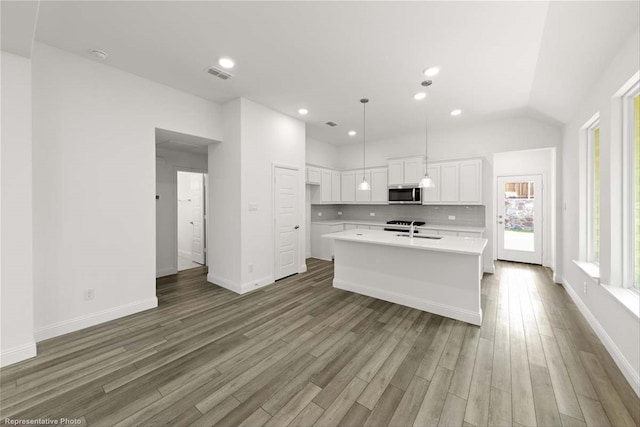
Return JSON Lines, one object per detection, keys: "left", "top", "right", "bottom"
{"left": 338, "top": 116, "right": 562, "bottom": 272}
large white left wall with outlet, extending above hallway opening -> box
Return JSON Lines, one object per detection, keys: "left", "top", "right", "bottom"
{"left": 33, "top": 43, "right": 222, "bottom": 340}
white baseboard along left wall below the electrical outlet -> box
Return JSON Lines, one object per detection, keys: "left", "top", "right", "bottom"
{"left": 34, "top": 297, "right": 158, "bottom": 342}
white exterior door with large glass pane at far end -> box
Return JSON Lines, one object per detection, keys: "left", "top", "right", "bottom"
{"left": 496, "top": 175, "right": 542, "bottom": 264}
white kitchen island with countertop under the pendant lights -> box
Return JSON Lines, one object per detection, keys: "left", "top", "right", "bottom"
{"left": 323, "top": 229, "right": 487, "bottom": 325}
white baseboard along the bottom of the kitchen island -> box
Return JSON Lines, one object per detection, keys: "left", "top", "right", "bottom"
{"left": 333, "top": 279, "right": 482, "bottom": 326}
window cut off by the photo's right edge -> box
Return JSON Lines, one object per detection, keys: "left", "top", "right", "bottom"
{"left": 622, "top": 82, "right": 640, "bottom": 290}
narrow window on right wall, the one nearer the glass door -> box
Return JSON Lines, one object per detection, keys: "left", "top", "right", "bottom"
{"left": 586, "top": 118, "right": 600, "bottom": 264}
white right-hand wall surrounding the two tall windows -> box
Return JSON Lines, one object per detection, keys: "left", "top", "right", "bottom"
{"left": 562, "top": 27, "right": 640, "bottom": 394}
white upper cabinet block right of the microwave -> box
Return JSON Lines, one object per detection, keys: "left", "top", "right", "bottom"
{"left": 423, "top": 159, "right": 482, "bottom": 205}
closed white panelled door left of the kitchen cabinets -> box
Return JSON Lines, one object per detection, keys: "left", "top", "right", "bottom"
{"left": 274, "top": 167, "right": 300, "bottom": 280}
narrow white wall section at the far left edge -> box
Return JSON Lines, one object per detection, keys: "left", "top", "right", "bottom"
{"left": 0, "top": 51, "right": 36, "bottom": 366}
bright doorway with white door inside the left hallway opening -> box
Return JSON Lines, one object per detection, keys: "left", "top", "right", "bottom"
{"left": 176, "top": 171, "right": 206, "bottom": 271}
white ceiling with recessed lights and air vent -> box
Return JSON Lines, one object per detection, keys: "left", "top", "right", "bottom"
{"left": 30, "top": 1, "right": 640, "bottom": 144}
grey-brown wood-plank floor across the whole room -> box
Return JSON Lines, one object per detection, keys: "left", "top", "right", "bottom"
{"left": 0, "top": 259, "right": 640, "bottom": 426}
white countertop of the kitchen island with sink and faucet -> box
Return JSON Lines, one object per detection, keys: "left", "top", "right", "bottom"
{"left": 322, "top": 229, "right": 487, "bottom": 255}
